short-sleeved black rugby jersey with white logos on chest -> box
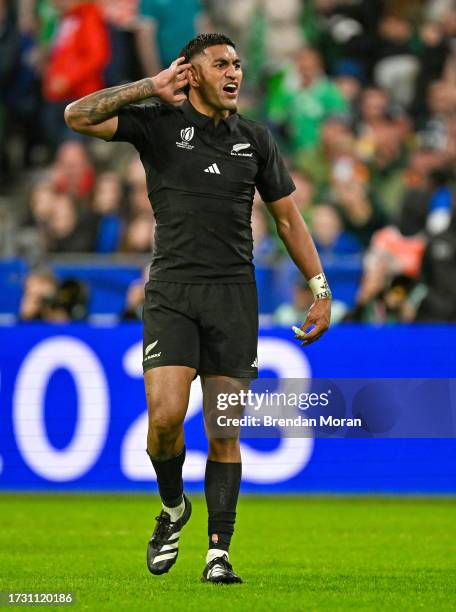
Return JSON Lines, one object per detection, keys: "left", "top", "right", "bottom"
{"left": 112, "top": 101, "right": 295, "bottom": 283}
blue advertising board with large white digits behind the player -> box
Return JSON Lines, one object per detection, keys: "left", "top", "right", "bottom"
{"left": 0, "top": 323, "right": 456, "bottom": 494}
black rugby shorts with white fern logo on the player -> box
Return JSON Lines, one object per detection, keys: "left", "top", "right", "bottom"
{"left": 143, "top": 280, "right": 258, "bottom": 378}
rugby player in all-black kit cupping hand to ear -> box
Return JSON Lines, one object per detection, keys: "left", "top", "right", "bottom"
{"left": 65, "top": 33, "right": 331, "bottom": 584}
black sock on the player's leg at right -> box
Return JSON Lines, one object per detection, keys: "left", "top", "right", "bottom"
{"left": 204, "top": 459, "right": 242, "bottom": 551}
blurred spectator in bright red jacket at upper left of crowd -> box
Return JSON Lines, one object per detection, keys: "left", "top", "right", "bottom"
{"left": 43, "top": 0, "right": 110, "bottom": 146}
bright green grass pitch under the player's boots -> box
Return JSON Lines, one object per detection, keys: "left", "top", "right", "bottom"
{"left": 0, "top": 494, "right": 456, "bottom": 612}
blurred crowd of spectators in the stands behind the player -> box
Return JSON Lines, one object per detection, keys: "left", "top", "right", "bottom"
{"left": 0, "top": 0, "right": 456, "bottom": 324}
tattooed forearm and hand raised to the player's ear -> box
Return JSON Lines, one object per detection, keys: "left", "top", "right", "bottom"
{"left": 65, "top": 57, "right": 190, "bottom": 140}
